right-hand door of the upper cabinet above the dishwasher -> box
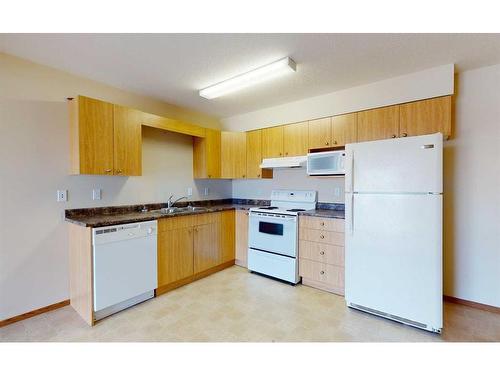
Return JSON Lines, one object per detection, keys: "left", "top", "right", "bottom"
{"left": 113, "top": 105, "right": 142, "bottom": 176}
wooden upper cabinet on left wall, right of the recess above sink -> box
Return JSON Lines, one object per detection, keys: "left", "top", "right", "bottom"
{"left": 193, "top": 129, "right": 221, "bottom": 178}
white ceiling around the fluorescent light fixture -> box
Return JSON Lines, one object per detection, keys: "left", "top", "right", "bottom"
{"left": 0, "top": 34, "right": 500, "bottom": 117}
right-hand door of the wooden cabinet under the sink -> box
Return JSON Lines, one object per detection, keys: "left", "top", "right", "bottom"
{"left": 194, "top": 223, "right": 221, "bottom": 273}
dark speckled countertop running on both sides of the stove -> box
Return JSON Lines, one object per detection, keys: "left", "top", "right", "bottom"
{"left": 65, "top": 199, "right": 345, "bottom": 228}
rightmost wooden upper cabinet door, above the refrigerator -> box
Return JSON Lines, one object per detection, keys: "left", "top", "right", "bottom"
{"left": 399, "top": 96, "right": 451, "bottom": 138}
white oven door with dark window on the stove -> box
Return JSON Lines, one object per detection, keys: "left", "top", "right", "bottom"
{"left": 248, "top": 212, "right": 297, "bottom": 257}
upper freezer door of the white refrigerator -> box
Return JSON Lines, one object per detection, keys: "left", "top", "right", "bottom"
{"left": 345, "top": 133, "right": 443, "bottom": 193}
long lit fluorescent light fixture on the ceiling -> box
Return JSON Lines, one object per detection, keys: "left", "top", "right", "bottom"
{"left": 200, "top": 57, "right": 296, "bottom": 99}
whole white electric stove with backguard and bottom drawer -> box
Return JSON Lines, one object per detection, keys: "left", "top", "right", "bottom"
{"left": 248, "top": 190, "right": 317, "bottom": 284}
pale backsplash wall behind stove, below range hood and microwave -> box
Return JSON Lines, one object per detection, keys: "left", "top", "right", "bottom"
{"left": 232, "top": 168, "right": 344, "bottom": 203}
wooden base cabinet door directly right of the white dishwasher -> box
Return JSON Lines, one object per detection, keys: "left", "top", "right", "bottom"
{"left": 158, "top": 226, "right": 193, "bottom": 287}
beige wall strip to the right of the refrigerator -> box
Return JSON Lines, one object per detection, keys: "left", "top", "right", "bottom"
{"left": 444, "top": 65, "right": 500, "bottom": 307}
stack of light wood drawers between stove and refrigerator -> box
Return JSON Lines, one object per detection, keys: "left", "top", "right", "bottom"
{"left": 299, "top": 216, "right": 344, "bottom": 295}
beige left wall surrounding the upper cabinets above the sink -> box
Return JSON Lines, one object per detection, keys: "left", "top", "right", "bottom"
{"left": 0, "top": 54, "right": 231, "bottom": 320}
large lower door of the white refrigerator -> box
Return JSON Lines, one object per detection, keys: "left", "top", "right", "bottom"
{"left": 345, "top": 194, "right": 443, "bottom": 331}
